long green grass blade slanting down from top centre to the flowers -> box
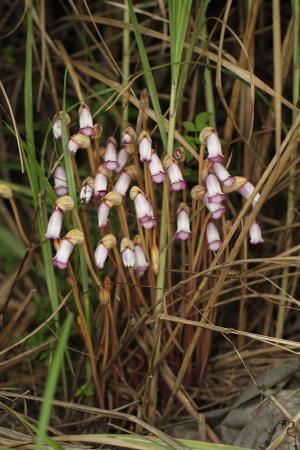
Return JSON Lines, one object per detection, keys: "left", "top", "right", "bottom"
{"left": 127, "top": 0, "right": 167, "bottom": 147}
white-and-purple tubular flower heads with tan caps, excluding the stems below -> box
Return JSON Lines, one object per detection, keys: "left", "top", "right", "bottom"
{"left": 50, "top": 103, "right": 263, "bottom": 275}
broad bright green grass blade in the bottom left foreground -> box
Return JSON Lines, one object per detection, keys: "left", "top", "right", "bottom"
{"left": 35, "top": 314, "right": 73, "bottom": 450}
